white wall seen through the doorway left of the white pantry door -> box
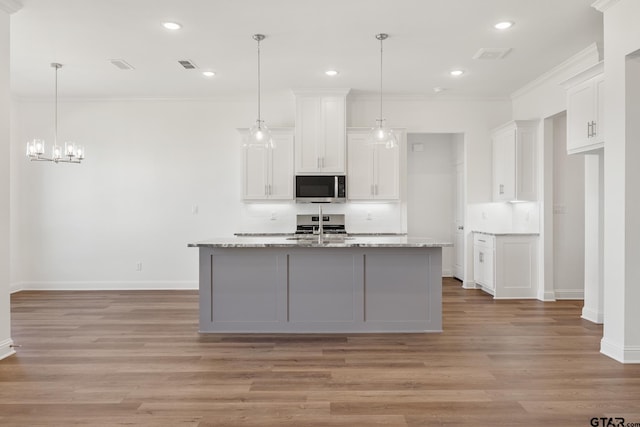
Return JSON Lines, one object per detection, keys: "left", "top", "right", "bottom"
{"left": 407, "top": 133, "right": 456, "bottom": 276}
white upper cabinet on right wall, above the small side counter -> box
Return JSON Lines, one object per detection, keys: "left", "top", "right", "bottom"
{"left": 491, "top": 120, "right": 538, "bottom": 202}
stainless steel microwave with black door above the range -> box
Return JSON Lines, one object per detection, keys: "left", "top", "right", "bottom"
{"left": 296, "top": 175, "right": 347, "bottom": 203}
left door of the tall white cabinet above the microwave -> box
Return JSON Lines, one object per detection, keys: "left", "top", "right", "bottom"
{"left": 296, "top": 97, "right": 322, "bottom": 173}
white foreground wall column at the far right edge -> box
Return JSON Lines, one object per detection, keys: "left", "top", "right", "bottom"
{"left": 601, "top": 0, "right": 640, "bottom": 363}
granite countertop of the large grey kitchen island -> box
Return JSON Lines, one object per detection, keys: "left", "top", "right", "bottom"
{"left": 188, "top": 235, "right": 453, "bottom": 248}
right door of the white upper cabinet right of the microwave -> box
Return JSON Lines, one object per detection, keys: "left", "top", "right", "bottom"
{"left": 373, "top": 145, "right": 400, "bottom": 200}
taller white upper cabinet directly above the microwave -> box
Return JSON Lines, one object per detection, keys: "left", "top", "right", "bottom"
{"left": 295, "top": 89, "right": 349, "bottom": 174}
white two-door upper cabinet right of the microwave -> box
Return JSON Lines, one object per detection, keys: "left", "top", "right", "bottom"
{"left": 347, "top": 129, "right": 404, "bottom": 200}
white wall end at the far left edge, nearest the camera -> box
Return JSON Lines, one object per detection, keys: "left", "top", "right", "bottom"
{"left": 0, "top": 8, "right": 13, "bottom": 359}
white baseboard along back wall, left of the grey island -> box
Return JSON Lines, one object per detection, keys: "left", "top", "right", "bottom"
{"left": 11, "top": 280, "right": 198, "bottom": 292}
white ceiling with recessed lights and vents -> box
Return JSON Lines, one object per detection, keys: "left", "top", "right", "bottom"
{"left": 11, "top": 0, "right": 602, "bottom": 98}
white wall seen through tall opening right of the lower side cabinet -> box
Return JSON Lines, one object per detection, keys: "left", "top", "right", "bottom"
{"left": 553, "top": 114, "right": 585, "bottom": 299}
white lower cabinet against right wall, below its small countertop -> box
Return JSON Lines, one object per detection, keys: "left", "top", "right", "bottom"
{"left": 473, "top": 232, "right": 538, "bottom": 298}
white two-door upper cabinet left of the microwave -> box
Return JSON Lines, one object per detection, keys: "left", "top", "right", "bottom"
{"left": 241, "top": 128, "right": 294, "bottom": 200}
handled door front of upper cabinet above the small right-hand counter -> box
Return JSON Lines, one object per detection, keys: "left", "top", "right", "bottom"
{"left": 493, "top": 128, "right": 516, "bottom": 202}
